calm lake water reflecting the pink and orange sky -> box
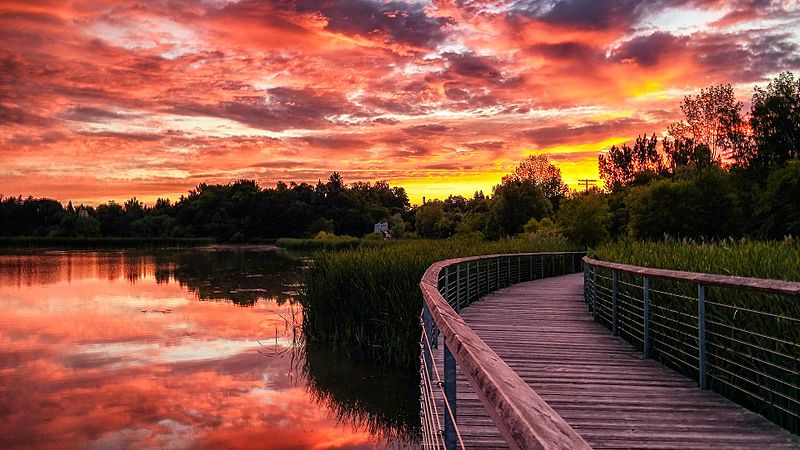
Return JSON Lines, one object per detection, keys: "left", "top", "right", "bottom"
{"left": 0, "top": 247, "right": 419, "bottom": 449}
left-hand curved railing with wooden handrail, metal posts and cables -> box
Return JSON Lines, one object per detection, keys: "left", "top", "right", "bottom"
{"left": 420, "top": 252, "right": 589, "bottom": 449}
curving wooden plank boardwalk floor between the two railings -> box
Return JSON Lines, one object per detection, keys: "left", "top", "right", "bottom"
{"left": 439, "top": 274, "right": 800, "bottom": 449}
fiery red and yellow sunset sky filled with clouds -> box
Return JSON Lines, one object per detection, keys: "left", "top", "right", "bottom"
{"left": 0, "top": 0, "right": 800, "bottom": 203}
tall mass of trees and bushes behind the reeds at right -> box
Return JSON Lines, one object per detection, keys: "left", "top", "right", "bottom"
{"left": 584, "top": 73, "right": 800, "bottom": 242}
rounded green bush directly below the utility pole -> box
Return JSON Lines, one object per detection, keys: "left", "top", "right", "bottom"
{"left": 557, "top": 191, "right": 611, "bottom": 247}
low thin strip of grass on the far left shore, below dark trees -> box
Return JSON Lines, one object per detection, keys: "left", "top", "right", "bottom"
{"left": 0, "top": 237, "right": 216, "bottom": 249}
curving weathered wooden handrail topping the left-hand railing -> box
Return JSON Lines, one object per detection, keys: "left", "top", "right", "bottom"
{"left": 419, "top": 252, "right": 591, "bottom": 449}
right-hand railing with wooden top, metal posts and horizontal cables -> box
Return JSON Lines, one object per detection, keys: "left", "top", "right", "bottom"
{"left": 583, "top": 257, "right": 800, "bottom": 433}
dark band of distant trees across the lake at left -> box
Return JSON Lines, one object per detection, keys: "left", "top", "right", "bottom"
{"left": 0, "top": 172, "right": 409, "bottom": 242}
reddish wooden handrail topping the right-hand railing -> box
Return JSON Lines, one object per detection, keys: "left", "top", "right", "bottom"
{"left": 583, "top": 256, "right": 800, "bottom": 297}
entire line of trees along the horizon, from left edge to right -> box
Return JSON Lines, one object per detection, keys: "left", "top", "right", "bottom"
{"left": 0, "top": 72, "right": 800, "bottom": 246}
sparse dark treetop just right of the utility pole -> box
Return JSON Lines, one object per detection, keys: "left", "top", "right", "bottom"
{"left": 597, "top": 134, "right": 664, "bottom": 191}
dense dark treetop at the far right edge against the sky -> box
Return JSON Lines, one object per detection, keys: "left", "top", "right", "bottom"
{"left": 733, "top": 72, "right": 800, "bottom": 171}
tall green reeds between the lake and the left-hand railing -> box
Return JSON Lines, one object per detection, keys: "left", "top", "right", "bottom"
{"left": 301, "top": 238, "right": 574, "bottom": 366}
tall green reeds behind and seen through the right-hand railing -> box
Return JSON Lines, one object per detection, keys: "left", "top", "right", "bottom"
{"left": 591, "top": 240, "right": 800, "bottom": 433}
